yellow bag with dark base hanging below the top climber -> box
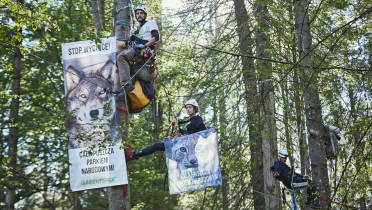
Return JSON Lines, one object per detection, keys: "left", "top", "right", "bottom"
{"left": 128, "top": 80, "right": 150, "bottom": 113}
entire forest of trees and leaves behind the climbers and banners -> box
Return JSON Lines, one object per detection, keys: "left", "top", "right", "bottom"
{"left": 0, "top": 0, "right": 372, "bottom": 210}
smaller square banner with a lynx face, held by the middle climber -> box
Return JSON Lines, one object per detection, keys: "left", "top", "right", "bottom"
{"left": 164, "top": 128, "right": 222, "bottom": 195}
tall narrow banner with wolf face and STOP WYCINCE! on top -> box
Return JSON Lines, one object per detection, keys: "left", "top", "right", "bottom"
{"left": 62, "top": 37, "right": 128, "bottom": 191}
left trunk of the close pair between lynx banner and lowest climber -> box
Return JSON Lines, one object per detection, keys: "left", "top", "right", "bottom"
{"left": 234, "top": 0, "right": 265, "bottom": 209}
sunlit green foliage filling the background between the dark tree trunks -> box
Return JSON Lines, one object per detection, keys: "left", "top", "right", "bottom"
{"left": 0, "top": 0, "right": 372, "bottom": 209}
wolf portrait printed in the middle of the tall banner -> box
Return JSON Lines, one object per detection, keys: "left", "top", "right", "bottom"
{"left": 63, "top": 53, "right": 121, "bottom": 149}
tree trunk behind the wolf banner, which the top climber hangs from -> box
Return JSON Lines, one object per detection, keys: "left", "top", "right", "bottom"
{"left": 109, "top": 0, "right": 131, "bottom": 210}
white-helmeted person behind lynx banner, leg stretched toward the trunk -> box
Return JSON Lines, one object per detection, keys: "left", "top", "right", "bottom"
{"left": 125, "top": 99, "right": 207, "bottom": 161}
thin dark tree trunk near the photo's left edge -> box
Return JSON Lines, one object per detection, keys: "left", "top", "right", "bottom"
{"left": 6, "top": 35, "right": 22, "bottom": 210}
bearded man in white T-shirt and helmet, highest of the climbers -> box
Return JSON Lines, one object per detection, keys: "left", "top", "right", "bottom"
{"left": 116, "top": 5, "right": 160, "bottom": 97}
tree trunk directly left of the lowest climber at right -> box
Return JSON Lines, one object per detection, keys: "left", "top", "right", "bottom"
{"left": 254, "top": 1, "right": 282, "bottom": 209}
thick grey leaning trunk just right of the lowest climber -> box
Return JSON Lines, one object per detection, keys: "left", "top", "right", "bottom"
{"left": 295, "top": 0, "right": 330, "bottom": 202}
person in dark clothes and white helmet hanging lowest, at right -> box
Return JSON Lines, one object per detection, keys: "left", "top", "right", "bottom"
{"left": 272, "top": 149, "right": 323, "bottom": 209}
